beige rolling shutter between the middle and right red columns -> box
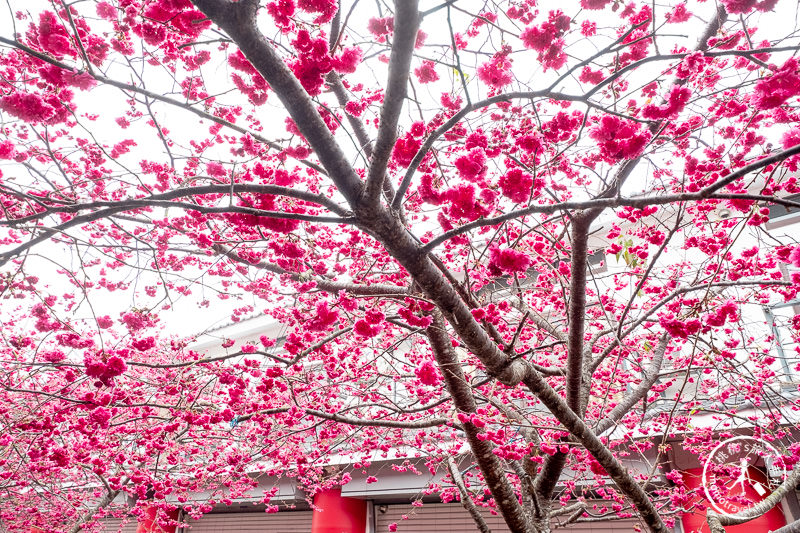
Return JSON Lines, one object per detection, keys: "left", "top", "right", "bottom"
{"left": 375, "top": 503, "right": 638, "bottom": 533}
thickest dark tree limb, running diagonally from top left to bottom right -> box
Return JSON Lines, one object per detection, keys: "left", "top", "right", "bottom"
{"left": 177, "top": 0, "right": 688, "bottom": 532}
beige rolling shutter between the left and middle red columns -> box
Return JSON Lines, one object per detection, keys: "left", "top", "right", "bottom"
{"left": 183, "top": 511, "right": 313, "bottom": 533}
